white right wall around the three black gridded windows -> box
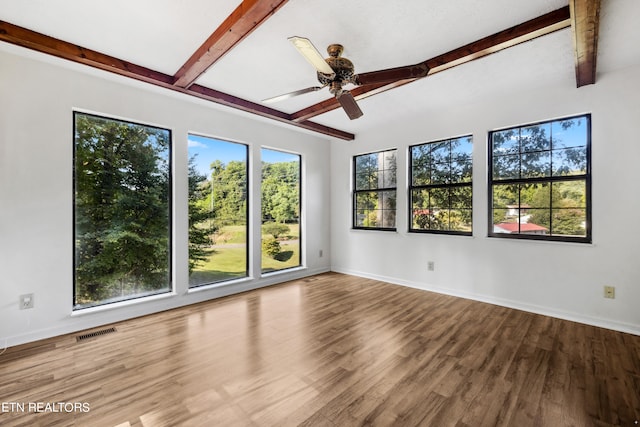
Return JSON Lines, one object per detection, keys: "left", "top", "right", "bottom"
{"left": 331, "top": 63, "right": 640, "bottom": 334}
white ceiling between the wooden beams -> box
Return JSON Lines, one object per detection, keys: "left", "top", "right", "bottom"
{"left": 0, "top": 0, "right": 640, "bottom": 134}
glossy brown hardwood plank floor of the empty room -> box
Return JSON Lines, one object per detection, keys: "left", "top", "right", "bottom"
{"left": 0, "top": 273, "right": 640, "bottom": 427}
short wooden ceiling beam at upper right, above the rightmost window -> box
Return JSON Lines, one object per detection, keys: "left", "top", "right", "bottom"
{"left": 569, "top": 0, "right": 600, "bottom": 87}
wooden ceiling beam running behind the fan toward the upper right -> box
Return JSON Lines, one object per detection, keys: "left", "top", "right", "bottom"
{"left": 291, "top": 5, "right": 568, "bottom": 120}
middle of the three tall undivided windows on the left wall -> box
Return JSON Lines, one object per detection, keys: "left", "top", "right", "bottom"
{"left": 188, "top": 134, "right": 249, "bottom": 287}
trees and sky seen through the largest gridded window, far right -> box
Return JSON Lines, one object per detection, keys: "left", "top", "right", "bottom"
{"left": 491, "top": 118, "right": 587, "bottom": 235}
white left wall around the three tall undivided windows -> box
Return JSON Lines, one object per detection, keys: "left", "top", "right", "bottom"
{"left": 0, "top": 44, "right": 330, "bottom": 351}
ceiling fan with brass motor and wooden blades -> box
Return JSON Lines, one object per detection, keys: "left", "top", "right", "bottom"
{"left": 262, "top": 37, "right": 429, "bottom": 120}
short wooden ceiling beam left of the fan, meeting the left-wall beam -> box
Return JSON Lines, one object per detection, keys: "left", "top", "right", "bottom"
{"left": 174, "top": 0, "right": 287, "bottom": 87}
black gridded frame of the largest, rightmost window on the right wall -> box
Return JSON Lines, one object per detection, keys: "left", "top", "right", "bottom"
{"left": 487, "top": 113, "right": 593, "bottom": 243}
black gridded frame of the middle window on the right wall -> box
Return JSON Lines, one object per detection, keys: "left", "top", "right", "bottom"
{"left": 407, "top": 134, "right": 473, "bottom": 236}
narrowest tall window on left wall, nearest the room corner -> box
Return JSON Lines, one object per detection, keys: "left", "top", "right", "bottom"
{"left": 261, "top": 148, "right": 302, "bottom": 273}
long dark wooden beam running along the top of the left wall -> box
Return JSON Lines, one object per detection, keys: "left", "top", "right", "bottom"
{"left": 0, "top": 21, "right": 355, "bottom": 141}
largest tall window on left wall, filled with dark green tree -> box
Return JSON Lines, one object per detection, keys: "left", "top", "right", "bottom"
{"left": 73, "top": 112, "right": 171, "bottom": 309}
